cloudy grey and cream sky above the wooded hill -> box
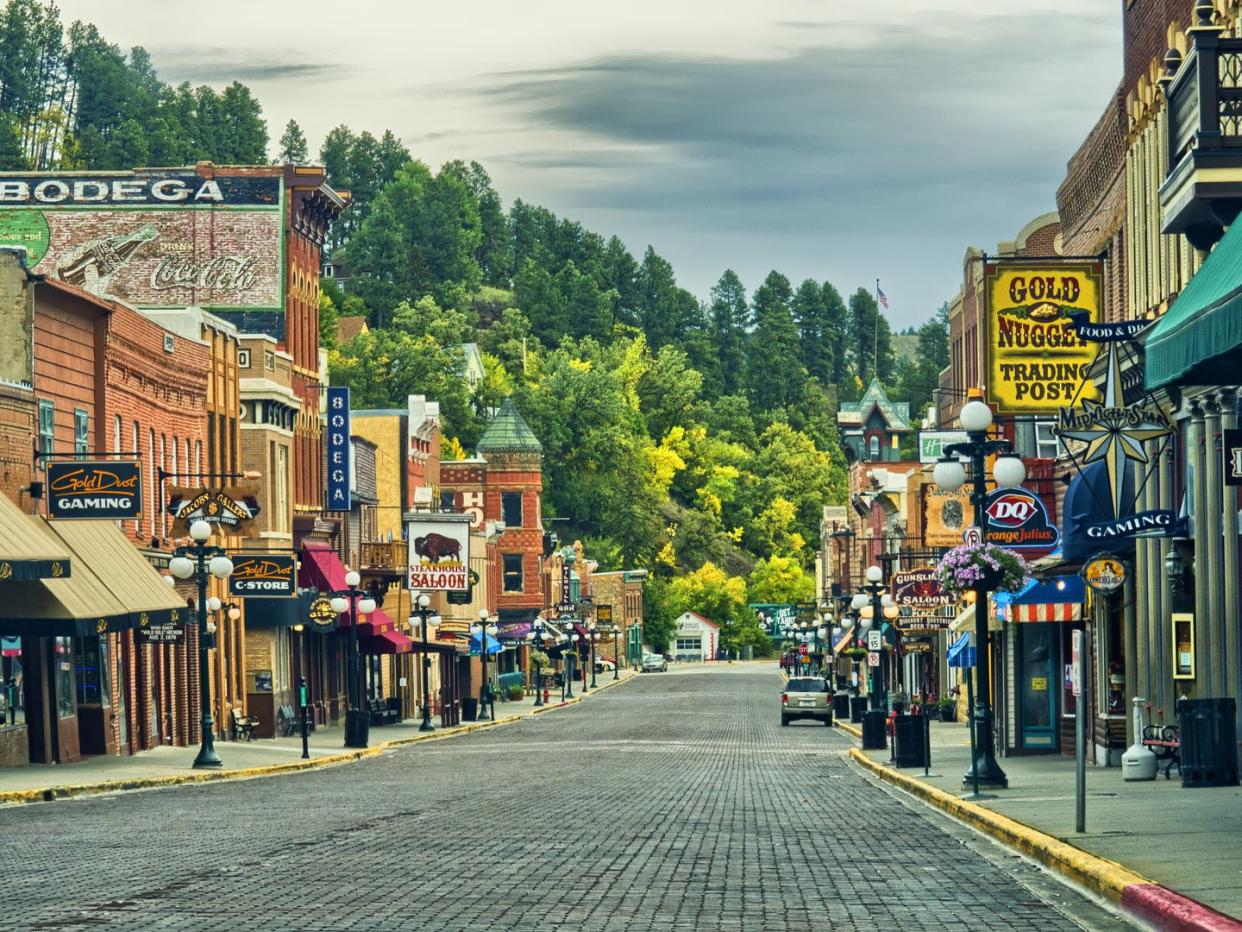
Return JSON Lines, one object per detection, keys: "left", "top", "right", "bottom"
{"left": 48, "top": 0, "right": 1122, "bottom": 328}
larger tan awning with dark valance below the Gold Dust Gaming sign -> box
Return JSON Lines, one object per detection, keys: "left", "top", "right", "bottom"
{"left": 0, "top": 517, "right": 189, "bottom": 637}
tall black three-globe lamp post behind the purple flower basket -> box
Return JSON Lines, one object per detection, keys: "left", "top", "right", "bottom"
{"left": 933, "top": 399, "right": 1026, "bottom": 787}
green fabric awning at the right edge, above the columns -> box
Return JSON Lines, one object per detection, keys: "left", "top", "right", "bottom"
{"left": 1145, "top": 224, "right": 1242, "bottom": 389}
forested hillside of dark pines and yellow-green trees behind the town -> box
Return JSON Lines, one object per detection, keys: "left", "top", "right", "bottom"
{"left": 0, "top": 0, "right": 948, "bottom": 645}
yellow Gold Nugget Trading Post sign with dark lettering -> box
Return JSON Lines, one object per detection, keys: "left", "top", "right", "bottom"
{"left": 984, "top": 261, "right": 1103, "bottom": 414}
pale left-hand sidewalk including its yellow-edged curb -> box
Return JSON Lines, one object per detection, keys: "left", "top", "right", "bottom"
{"left": 0, "top": 671, "right": 636, "bottom": 804}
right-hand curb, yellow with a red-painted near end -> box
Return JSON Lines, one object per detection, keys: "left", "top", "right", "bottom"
{"left": 842, "top": 750, "right": 1242, "bottom": 932}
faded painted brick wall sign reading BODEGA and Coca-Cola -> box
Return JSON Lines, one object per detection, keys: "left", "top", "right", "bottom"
{"left": 0, "top": 171, "right": 283, "bottom": 312}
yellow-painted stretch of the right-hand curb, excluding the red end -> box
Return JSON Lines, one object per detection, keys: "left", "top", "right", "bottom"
{"left": 850, "top": 748, "right": 1153, "bottom": 902}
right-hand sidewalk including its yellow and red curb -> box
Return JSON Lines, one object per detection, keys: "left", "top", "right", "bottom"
{"left": 842, "top": 722, "right": 1242, "bottom": 930}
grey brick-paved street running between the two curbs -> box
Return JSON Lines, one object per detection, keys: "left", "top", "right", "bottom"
{"left": 0, "top": 665, "right": 1122, "bottom": 932}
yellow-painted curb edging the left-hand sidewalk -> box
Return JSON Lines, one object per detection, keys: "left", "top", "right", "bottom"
{"left": 0, "top": 676, "right": 633, "bottom": 805}
